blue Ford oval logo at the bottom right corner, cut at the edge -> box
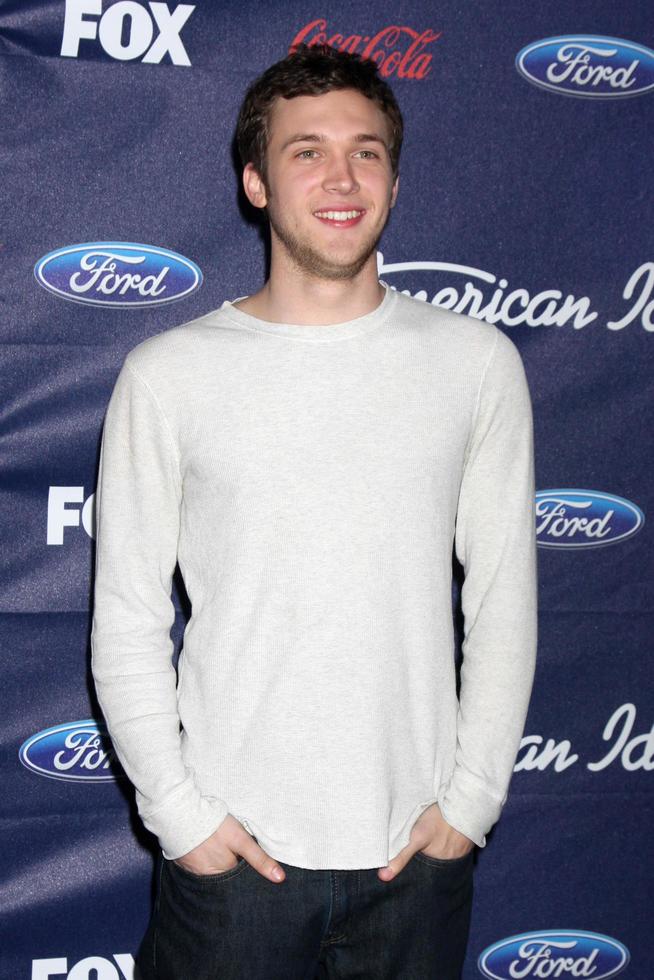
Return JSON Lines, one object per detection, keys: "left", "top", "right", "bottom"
{"left": 477, "top": 929, "right": 630, "bottom": 980}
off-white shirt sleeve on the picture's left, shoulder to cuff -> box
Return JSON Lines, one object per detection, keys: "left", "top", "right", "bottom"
{"left": 91, "top": 359, "right": 228, "bottom": 858}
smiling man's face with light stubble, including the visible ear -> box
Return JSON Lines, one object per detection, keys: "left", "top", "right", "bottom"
{"left": 244, "top": 89, "right": 397, "bottom": 279}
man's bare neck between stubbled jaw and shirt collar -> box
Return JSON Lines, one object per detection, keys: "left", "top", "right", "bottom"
{"left": 237, "top": 249, "right": 384, "bottom": 325}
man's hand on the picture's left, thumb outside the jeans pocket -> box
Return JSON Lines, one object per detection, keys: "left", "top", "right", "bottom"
{"left": 175, "top": 813, "right": 286, "bottom": 884}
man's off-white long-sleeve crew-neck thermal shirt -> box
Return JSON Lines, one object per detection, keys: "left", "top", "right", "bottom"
{"left": 91, "top": 287, "right": 537, "bottom": 869}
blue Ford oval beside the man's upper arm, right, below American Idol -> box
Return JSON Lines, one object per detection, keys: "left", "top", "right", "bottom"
{"left": 536, "top": 489, "right": 645, "bottom": 548}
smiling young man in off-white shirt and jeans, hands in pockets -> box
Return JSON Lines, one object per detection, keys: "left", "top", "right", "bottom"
{"left": 92, "top": 48, "right": 536, "bottom": 980}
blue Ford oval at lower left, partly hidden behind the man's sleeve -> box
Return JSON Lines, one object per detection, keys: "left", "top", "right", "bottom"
{"left": 18, "top": 720, "right": 124, "bottom": 783}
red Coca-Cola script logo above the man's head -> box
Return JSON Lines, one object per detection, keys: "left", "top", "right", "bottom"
{"left": 289, "top": 17, "right": 443, "bottom": 79}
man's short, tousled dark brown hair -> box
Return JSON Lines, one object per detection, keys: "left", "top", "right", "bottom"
{"left": 236, "top": 44, "right": 404, "bottom": 183}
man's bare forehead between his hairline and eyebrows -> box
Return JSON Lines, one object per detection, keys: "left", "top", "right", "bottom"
{"left": 268, "top": 89, "right": 390, "bottom": 145}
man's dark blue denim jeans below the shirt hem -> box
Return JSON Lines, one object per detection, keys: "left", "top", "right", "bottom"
{"left": 137, "top": 851, "right": 473, "bottom": 980}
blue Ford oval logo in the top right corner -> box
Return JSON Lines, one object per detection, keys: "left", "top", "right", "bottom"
{"left": 515, "top": 34, "right": 654, "bottom": 99}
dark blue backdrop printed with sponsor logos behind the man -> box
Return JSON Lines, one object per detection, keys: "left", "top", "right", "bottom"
{"left": 0, "top": 0, "right": 654, "bottom": 980}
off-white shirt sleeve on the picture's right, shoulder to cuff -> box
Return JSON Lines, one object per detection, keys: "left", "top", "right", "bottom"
{"left": 440, "top": 330, "right": 537, "bottom": 847}
